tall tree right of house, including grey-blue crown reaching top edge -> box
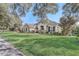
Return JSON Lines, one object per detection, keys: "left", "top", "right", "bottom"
{"left": 60, "top": 3, "right": 79, "bottom": 35}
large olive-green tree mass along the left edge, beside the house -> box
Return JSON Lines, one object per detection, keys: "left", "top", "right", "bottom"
{"left": 0, "top": 4, "right": 22, "bottom": 30}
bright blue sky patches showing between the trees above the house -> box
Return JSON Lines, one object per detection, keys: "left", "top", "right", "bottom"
{"left": 22, "top": 3, "right": 64, "bottom": 24}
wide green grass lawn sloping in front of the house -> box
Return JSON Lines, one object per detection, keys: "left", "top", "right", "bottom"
{"left": 0, "top": 32, "right": 79, "bottom": 56}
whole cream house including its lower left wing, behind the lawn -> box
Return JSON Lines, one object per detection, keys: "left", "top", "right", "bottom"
{"left": 23, "top": 19, "right": 61, "bottom": 33}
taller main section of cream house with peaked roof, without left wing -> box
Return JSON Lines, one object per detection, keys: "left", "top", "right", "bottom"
{"left": 34, "top": 19, "right": 61, "bottom": 33}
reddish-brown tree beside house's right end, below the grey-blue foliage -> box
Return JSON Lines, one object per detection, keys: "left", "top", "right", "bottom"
{"left": 60, "top": 16, "right": 77, "bottom": 35}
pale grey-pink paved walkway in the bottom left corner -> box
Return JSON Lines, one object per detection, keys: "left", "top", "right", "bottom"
{"left": 0, "top": 38, "right": 23, "bottom": 56}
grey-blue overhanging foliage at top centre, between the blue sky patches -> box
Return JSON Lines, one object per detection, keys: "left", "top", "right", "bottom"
{"left": 33, "top": 3, "right": 58, "bottom": 18}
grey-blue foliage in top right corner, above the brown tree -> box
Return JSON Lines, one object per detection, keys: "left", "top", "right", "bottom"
{"left": 63, "top": 3, "right": 79, "bottom": 16}
